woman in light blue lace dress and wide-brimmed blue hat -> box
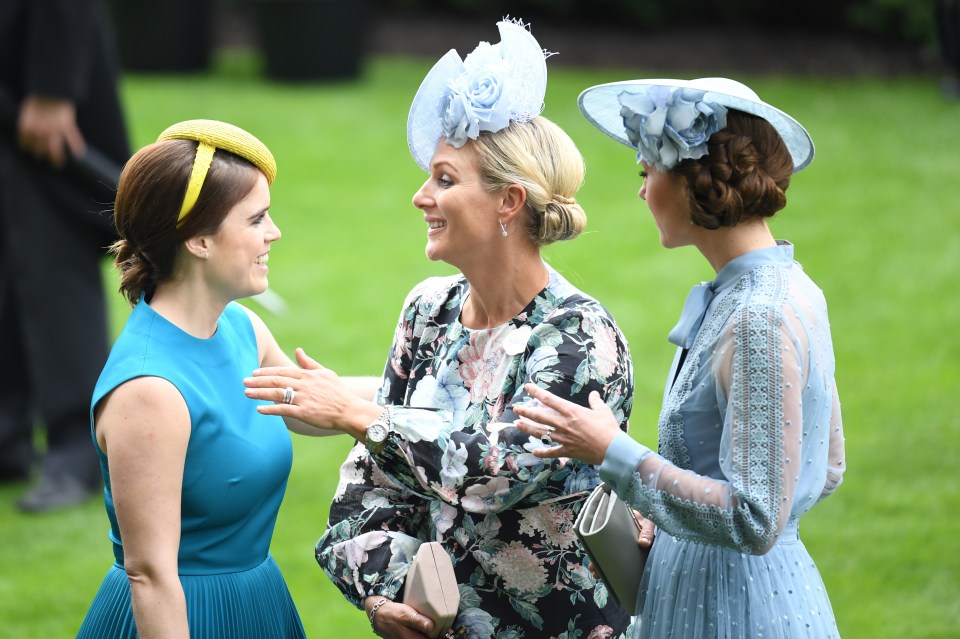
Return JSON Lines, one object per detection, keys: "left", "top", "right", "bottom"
{"left": 516, "top": 78, "right": 844, "bottom": 639}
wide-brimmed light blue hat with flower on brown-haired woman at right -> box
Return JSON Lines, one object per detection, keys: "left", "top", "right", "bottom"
{"left": 577, "top": 78, "right": 814, "bottom": 173}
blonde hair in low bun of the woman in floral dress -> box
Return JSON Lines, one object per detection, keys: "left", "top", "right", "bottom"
{"left": 473, "top": 116, "right": 587, "bottom": 246}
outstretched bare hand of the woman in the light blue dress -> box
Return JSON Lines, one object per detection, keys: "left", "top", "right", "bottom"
{"left": 514, "top": 384, "right": 620, "bottom": 464}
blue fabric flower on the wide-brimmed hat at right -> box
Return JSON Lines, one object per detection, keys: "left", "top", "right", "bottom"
{"left": 618, "top": 86, "right": 727, "bottom": 170}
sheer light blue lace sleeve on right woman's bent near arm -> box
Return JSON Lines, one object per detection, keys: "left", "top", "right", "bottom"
{"left": 601, "top": 290, "right": 810, "bottom": 554}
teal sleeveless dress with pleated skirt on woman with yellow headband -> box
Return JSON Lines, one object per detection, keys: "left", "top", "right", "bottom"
{"left": 78, "top": 297, "right": 305, "bottom": 639}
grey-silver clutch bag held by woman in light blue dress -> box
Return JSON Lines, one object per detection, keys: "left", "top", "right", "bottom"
{"left": 574, "top": 484, "right": 648, "bottom": 615}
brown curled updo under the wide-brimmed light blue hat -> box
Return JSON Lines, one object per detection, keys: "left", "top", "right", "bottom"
{"left": 671, "top": 109, "right": 793, "bottom": 229}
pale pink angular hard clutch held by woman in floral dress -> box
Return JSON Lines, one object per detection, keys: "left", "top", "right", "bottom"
{"left": 403, "top": 541, "right": 460, "bottom": 639}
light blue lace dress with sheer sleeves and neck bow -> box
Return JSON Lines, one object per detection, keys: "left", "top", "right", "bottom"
{"left": 600, "top": 244, "right": 844, "bottom": 639}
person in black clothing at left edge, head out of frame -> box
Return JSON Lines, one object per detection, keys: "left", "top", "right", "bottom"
{"left": 0, "top": 0, "right": 130, "bottom": 512}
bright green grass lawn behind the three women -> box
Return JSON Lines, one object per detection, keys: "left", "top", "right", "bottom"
{"left": 0, "top": 54, "right": 960, "bottom": 639}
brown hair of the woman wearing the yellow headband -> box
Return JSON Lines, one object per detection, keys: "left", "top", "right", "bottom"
{"left": 110, "top": 140, "right": 258, "bottom": 306}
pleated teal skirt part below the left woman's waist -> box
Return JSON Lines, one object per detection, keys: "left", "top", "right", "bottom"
{"left": 77, "top": 556, "right": 306, "bottom": 639}
